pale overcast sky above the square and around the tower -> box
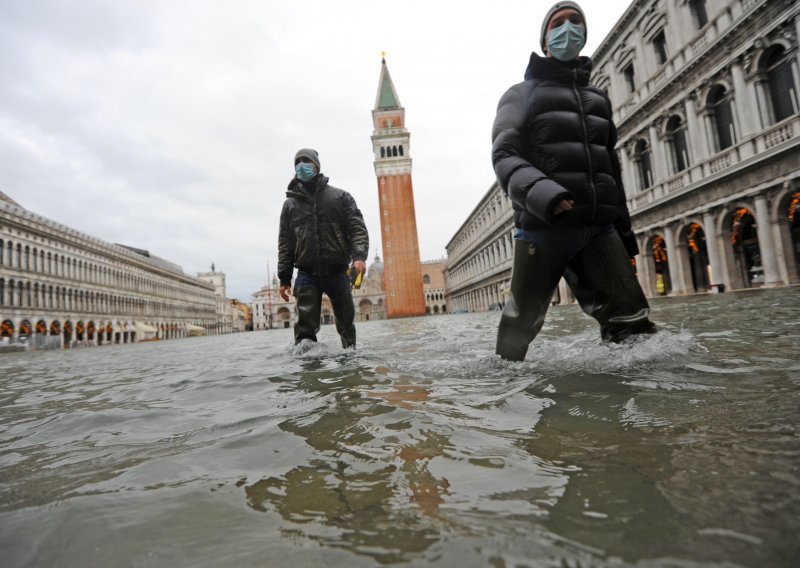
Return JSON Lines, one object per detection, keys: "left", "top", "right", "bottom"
{"left": 0, "top": 0, "right": 631, "bottom": 302}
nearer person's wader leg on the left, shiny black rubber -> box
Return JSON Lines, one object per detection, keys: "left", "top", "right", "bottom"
{"left": 495, "top": 240, "right": 565, "bottom": 361}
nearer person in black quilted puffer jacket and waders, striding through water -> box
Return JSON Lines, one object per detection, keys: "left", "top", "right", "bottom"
{"left": 492, "top": 2, "right": 655, "bottom": 361}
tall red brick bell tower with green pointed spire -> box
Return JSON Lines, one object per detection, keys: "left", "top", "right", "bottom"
{"left": 372, "top": 58, "right": 425, "bottom": 318}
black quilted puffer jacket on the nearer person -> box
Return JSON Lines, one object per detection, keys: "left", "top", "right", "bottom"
{"left": 492, "top": 53, "right": 635, "bottom": 246}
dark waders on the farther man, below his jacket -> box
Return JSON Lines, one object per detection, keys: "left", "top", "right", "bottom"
{"left": 294, "top": 270, "right": 356, "bottom": 347}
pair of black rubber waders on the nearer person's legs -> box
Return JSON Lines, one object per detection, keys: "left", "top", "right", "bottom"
{"left": 496, "top": 227, "right": 655, "bottom": 361}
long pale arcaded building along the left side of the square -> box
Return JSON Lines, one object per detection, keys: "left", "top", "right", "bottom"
{"left": 0, "top": 192, "right": 219, "bottom": 348}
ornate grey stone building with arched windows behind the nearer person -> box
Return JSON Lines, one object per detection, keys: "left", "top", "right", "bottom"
{"left": 446, "top": 0, "right": 800, "bottom": 312}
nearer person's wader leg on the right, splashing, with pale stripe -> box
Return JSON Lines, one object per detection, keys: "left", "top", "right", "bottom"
{"left": 564, "top": 231, "right": 656, "bottom": 342}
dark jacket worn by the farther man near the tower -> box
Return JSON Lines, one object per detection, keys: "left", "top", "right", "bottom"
{"left": 278, "top": 175, "right": 369, "bottom": 286}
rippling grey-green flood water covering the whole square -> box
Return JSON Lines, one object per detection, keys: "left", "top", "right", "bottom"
{"left": 0, "top": 287, "right": 800, "bottom": 568}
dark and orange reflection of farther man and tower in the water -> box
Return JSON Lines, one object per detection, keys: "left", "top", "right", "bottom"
{"left": 245, "top": 361, "right": 448, "bottom": 562}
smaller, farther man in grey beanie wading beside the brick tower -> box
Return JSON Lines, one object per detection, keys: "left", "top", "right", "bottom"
{"left": 278, "top": 148, "right": 369, "bottom": 347}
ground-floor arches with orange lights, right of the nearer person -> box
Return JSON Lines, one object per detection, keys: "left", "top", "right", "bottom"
{"left": 638, "top": 180, "right": 800, "bottom": 296}
